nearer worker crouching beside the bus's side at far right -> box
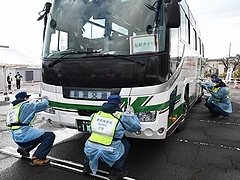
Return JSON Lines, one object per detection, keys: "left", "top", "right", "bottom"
{"left": 202, "top": 78, "right": 232, "bottom": 119}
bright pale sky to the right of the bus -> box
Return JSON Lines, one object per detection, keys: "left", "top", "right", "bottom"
{"left": 187, "top": 0, "right": 240, "bottom": 59}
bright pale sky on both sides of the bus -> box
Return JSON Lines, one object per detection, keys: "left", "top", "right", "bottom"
{"left": 0, "top": 0, "right": 240, "bottom": 62}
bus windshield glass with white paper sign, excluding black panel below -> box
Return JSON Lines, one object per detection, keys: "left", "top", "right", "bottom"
{"left": 43, "top": 0, "right": 165, "bottom": 58}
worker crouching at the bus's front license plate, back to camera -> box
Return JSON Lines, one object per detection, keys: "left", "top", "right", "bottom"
{"left": 83, "top": 95, "right": 141, "bottom": 180}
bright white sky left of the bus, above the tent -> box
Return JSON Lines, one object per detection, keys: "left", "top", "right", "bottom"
{"left": 0, "top": 0, "right": 47, "bottom": 62}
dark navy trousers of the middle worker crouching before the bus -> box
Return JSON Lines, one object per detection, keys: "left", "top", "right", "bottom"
{"left": 84, "top": 139, "right": 130, "bottom": 171}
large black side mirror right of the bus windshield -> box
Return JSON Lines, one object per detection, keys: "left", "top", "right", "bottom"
{"left": 165, "top": 0, "right": 180, "bottom": 28}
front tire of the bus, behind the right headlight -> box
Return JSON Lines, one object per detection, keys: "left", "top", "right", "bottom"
{"left": 176, "top": 91, "right": 189, "bottom": 132}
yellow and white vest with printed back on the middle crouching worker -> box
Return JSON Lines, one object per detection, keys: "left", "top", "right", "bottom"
{"left": 88, "top": 111, "right": 122, "bottom": 146}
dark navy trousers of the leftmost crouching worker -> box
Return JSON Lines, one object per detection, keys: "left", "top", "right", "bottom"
{"left": 17, "top": 132, "right": 55, "bottom": 160}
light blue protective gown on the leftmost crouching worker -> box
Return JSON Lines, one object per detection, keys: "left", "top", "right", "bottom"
{"left": 11, "top": 99, "right": 48, "bottom": 143}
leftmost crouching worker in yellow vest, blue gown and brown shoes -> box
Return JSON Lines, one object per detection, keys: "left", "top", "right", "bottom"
{"left": 6, "top": 91, "right": 55, "bottom": 166}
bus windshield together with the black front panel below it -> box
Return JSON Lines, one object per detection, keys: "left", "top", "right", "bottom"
{"left": 42, "top": 0, "right": 169, "bottom": 88}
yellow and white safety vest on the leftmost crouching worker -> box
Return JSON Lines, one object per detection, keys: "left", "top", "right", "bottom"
{"left": 6, "top": 101, "right": 34, "bottom": 130}
